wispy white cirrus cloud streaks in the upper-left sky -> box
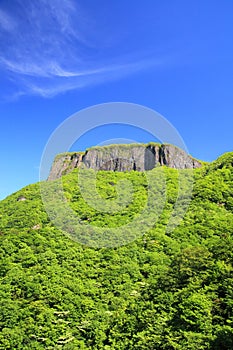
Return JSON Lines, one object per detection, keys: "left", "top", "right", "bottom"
{"left": 0, "top": 0, "right": 164, "bottom": 97}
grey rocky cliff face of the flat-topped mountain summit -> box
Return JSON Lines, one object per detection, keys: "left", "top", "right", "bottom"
{"left": 48, "top": 143, "right": 202, "bottom": 180}
